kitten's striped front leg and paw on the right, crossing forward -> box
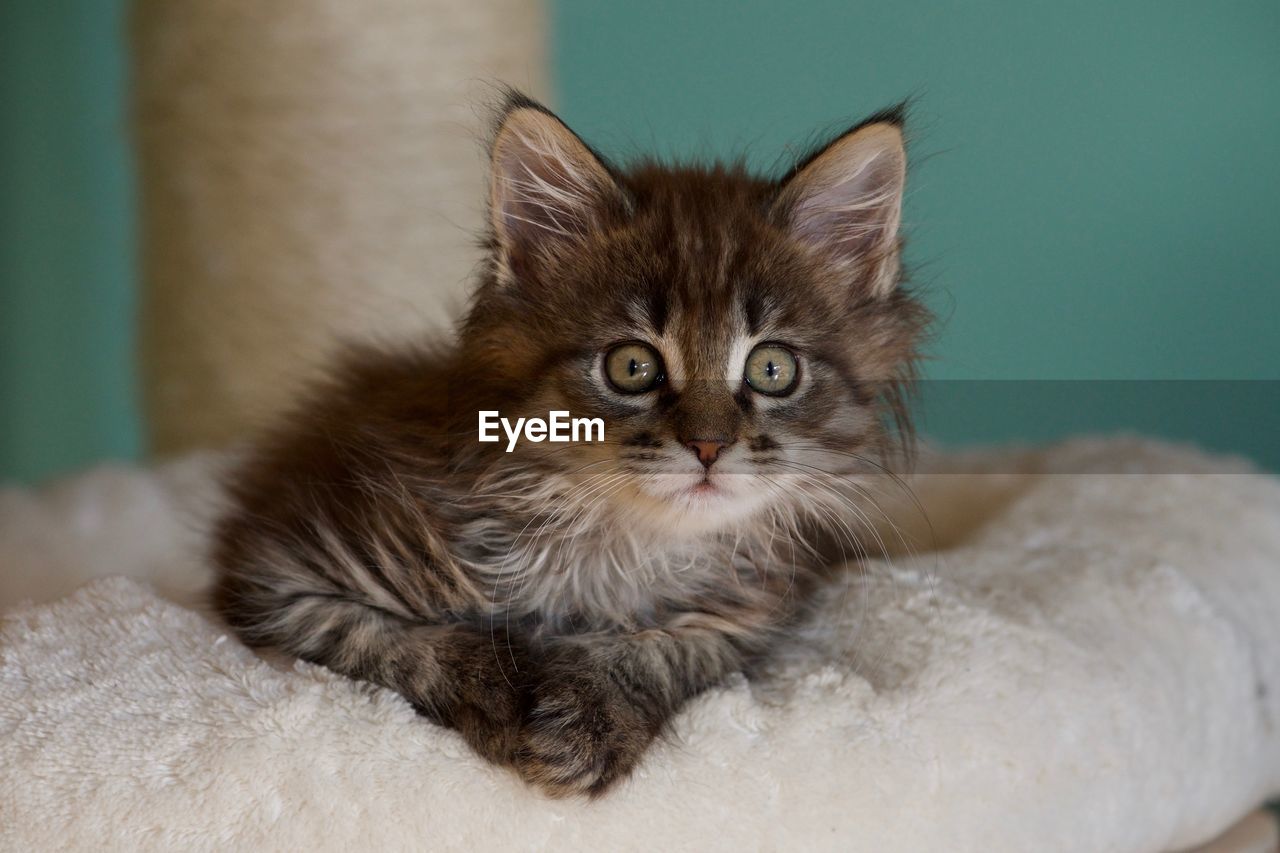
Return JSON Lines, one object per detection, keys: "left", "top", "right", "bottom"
{"left": 516, "top": 613, "right": 765, "bottom": 797}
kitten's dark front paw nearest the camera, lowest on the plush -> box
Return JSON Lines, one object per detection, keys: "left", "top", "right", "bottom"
{"left": 516, "top": 670, "right": 658, "bottom": 797}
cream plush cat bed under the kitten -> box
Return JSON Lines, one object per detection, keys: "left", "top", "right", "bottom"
{"left": 0, "top": 441, "right": 1280, "bottom": 852}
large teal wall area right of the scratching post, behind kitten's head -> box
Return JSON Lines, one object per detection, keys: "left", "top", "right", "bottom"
{"left": 553, "top": 0, "right": 1280, "bottom": 467}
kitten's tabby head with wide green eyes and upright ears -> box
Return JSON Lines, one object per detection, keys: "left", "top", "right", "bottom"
{"left": 463, "top": 99, "right": 923, "bottom": 533}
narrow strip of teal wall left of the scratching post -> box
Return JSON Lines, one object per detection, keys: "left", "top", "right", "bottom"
{"left": 0, "top": 0, "right": 140, "bottom": 480}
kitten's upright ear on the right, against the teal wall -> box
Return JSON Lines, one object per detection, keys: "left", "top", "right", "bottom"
{"left": 772, "top": 111, "right": 906, "bottom": 296}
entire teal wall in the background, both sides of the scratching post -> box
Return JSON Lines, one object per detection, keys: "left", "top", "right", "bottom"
{"left": 0, "top": 0, "right": 1280, "bottom": 482}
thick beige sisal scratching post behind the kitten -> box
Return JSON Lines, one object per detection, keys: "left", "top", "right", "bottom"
{"left": 133, "top": 0, "right": 544, "bottom": 453}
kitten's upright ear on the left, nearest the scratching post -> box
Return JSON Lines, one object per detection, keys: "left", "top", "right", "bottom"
{"left": 489, "top": 96, "right": 626, "bottom": 266}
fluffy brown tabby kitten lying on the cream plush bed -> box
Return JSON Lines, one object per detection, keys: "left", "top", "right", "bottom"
{"left": 215, "top": 95, "right": 925, "bottom": 795}
